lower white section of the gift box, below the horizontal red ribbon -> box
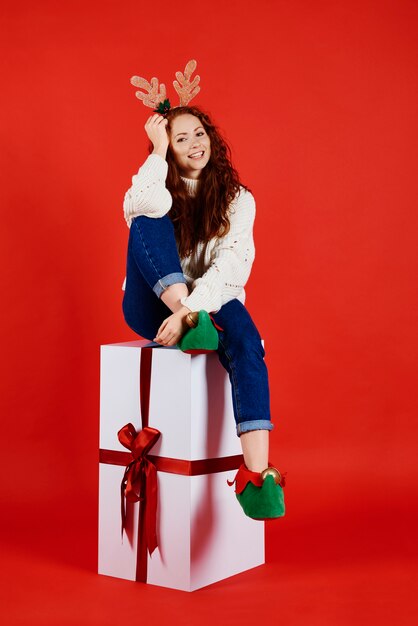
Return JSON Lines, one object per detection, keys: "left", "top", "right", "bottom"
{"left": 99, "top": 464, "right": 264, "bottom": 591}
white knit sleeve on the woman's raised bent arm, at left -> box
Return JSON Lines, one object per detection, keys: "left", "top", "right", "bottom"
{"left": 123, "top": 154, "right": 172, "bottom": 227}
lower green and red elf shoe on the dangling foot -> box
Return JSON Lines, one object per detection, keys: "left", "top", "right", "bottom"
{"left": 228, "top": 463, "right": 285, "bottom": 520}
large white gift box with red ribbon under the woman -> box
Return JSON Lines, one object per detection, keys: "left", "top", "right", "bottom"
{"left": 98, "top": 340, "right": 265, "bottom": 591}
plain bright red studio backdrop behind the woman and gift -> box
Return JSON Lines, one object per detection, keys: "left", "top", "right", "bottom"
{"left": 0, "top": 0, "right": 418, "bottom": 626}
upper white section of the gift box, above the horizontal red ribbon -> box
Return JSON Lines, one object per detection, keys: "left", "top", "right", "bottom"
{"left": 100, "top": 341, "right": 241, "bottom": 460}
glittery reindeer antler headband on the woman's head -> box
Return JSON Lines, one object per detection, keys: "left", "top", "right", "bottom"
{"left": 131, "top": 59, "right": 200, "bottom": 115}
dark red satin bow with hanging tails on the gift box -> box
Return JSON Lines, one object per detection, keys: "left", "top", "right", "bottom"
{"left": 118, "top": 424, "right": 161, "bottom": 554}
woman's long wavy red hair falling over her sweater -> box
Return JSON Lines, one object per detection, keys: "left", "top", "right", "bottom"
{"left": 150, "top": 106, "right": 250, "bottom": 258}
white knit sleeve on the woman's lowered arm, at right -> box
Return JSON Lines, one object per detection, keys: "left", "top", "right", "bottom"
{"left": 181, "top": 188, "right": 255, "bottom": 312}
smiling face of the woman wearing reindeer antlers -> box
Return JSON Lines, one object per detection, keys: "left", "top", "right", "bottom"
{"left": 170, "top": 113, "right": 210, "bottom": 178}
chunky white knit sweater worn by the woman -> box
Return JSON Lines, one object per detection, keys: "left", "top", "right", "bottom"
{"left": 122, "top": 154, "right": 255, "bottom": 312}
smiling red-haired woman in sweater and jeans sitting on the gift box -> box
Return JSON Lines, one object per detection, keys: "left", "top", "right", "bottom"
{"left": 119, "top": 106, "right": 285, "bottom": 519}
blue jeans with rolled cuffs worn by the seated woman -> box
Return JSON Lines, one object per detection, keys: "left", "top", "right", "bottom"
{"left": 122, "top": 215, "right": 273, "bottom": 436}
